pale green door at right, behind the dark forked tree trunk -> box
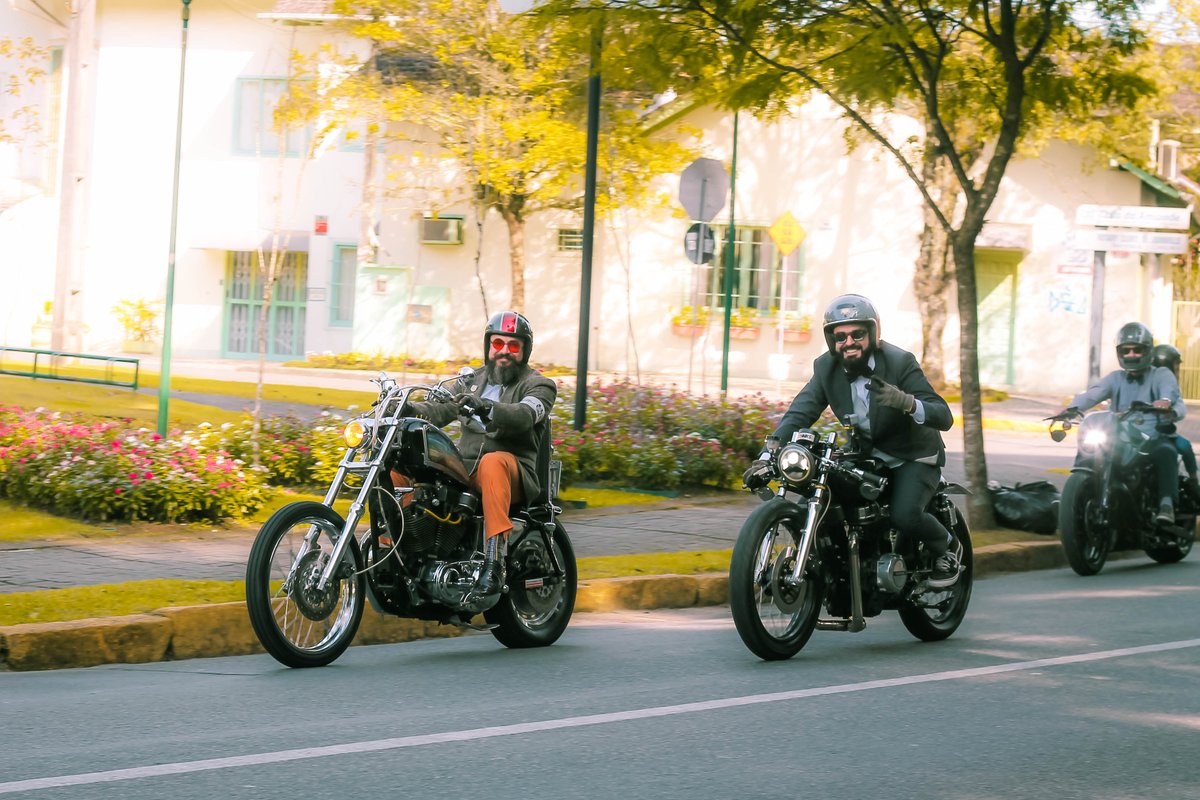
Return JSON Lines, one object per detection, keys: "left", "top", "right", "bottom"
{"left": 976, "top": 249, "right": 1021, "bottom": 386}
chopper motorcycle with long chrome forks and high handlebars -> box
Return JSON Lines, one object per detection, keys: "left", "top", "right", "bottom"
{"left": 246, "top": 368, "right": 578, "bottom": 667}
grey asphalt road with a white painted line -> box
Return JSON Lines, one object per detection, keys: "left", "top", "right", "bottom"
{"left": 0, "top": 559, "right": 1200, "bottom": 800}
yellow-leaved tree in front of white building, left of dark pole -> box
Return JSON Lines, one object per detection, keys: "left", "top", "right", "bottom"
{"left": 288, "top": 0, "right": 691, "bottom": 309}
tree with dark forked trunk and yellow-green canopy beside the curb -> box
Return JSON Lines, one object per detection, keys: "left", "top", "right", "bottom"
{"left": 549, "top": 0, "right": 1154, "bottom": 527}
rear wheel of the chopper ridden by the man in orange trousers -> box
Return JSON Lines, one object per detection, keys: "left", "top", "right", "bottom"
{"left": 484, "top": 523, "right": 578, "bottom": 648}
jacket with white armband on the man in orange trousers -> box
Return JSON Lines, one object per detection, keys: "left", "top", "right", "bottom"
{"left": 412, "top": 366, "right": 558, "bottom": 500}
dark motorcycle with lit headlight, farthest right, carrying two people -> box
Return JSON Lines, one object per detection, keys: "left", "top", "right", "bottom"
{"left": 1046, "top": 402, "right": 1196, "bottom": 576}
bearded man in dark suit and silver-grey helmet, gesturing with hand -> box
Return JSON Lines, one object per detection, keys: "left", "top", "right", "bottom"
{"left": 743, "top": 294, "right": 962, "bottom": 588}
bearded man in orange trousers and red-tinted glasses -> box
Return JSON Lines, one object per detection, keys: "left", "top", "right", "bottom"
{"left": 410, "top": 311, "right": 558, "bottom": 595}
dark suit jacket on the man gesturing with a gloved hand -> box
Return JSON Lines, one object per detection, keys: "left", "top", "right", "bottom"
{"left": 775, "top": 342, "right": 954, "bottom": 467}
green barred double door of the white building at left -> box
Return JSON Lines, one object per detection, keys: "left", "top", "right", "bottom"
{"left": 221, "top": 252, "right": 308, "bottom": 361}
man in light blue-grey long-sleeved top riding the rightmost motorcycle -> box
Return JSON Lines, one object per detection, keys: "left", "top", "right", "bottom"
{"left": 1062, "top": 323, "right": 1188, "bottom": 525}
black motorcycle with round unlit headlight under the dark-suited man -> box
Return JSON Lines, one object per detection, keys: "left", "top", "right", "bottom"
{"left": 730, "top": 427, "right": 974, "bottom": 661}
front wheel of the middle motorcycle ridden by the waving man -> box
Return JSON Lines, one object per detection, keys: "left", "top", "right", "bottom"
{"left": 730, "top": 500, "right": 824, "bottom": 661}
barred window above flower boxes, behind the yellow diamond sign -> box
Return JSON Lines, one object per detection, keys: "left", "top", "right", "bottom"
{"left": 703, "top": 227, "right": 804, "bottom": 314}
